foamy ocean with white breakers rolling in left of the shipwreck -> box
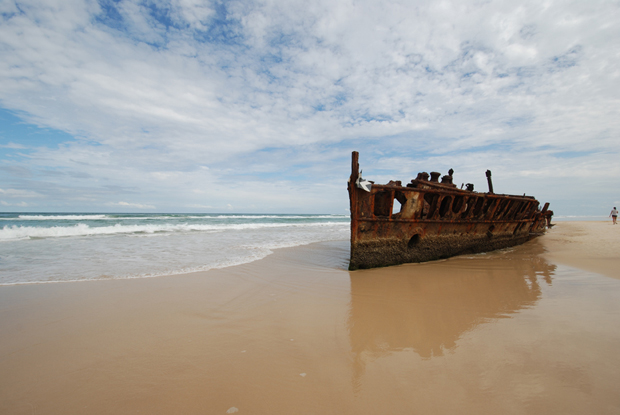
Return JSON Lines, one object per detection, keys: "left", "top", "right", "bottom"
{"left": 0, "top": 213, "right": 350, "bottom": 285}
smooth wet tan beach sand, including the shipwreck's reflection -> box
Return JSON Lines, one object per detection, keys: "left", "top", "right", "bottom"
{"left": 0, "top": 222, "right": 620, "bottom": 414}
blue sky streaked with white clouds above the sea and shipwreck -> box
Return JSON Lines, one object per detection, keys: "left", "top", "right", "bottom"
{"left": 0, "top": 0, "right": 620, "bottom": 216}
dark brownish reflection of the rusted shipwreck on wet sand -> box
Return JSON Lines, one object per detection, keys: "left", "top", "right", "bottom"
{"left": 348, "top": 243, "right": 556, "bottom": 381}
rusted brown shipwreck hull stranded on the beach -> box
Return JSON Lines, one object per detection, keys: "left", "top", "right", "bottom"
{"left": 348, "top": 151, "right": 553, "bottom": 270}
